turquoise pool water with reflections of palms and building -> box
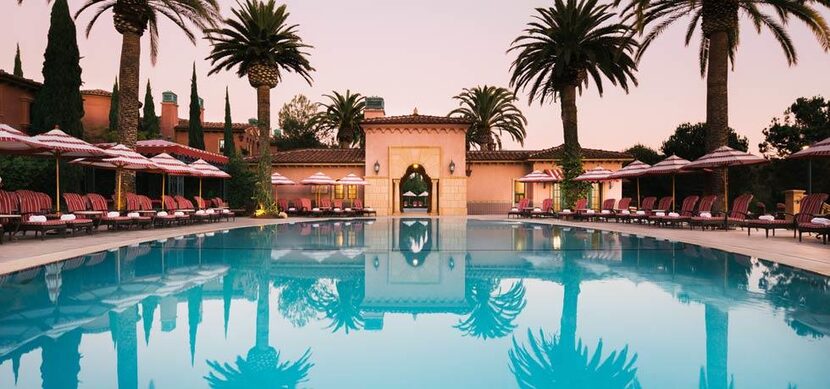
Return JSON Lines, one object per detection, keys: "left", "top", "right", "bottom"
{"left": 0, "top": 219, "right": 830, "bottom": 389}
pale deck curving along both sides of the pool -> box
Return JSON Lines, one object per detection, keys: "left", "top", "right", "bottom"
{"left": 0, "top": 215, "right": 830, "bottom": 276}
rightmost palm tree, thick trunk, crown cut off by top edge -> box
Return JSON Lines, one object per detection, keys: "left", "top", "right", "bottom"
{"left": 628, "top": 0, "right": 830, "bottom": 193}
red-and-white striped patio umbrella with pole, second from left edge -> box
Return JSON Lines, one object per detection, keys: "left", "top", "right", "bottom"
{"left": 33, "top": 127, "right": 110, "bottom": 213}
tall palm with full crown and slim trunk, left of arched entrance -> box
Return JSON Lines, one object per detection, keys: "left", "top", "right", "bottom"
{"left": 207, "top": 0, "right": 314, "bottom": 209}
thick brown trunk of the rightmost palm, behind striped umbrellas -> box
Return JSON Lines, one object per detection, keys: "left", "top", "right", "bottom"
{"left": 706, "top": 31, "right": 729, "bottom": 195}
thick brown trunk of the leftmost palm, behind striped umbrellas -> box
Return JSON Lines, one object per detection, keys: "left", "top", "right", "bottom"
{"left": 118, "top": 31, "right": 141, "bottom": 193}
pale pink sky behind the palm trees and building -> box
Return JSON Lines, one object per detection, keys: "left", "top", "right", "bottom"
{"left": 0, "top": 0, "right": 830, "bottom": 150}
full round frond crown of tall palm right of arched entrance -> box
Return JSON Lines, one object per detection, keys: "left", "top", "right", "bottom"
{"left": 509, "top": 0, "right": 639, "bottom": 103}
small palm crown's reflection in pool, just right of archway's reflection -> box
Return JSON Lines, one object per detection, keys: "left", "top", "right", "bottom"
{"left": 455, "top": 279, "right": 526, "bottom": 339}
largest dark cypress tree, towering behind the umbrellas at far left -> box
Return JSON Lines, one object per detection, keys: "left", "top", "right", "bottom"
{"left": 31, "top": 0, "right": 84, "bottom": 138}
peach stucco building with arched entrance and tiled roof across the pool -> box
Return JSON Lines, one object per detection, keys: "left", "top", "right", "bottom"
{"left": 260, "top": 97, "right": 632, "bottom": 215}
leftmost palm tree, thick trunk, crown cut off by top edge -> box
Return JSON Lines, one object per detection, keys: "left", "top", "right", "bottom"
{"left": 75, "top": 0, "right": 220, "bottom": 147}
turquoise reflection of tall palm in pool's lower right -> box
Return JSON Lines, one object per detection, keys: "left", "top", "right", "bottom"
{"left": 508, "top": 258, "right": 640, "bottom": 388}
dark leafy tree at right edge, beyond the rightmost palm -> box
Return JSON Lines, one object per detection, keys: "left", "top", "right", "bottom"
{"left": 758, "top": 96, "right": 830, "bottom": 157}
